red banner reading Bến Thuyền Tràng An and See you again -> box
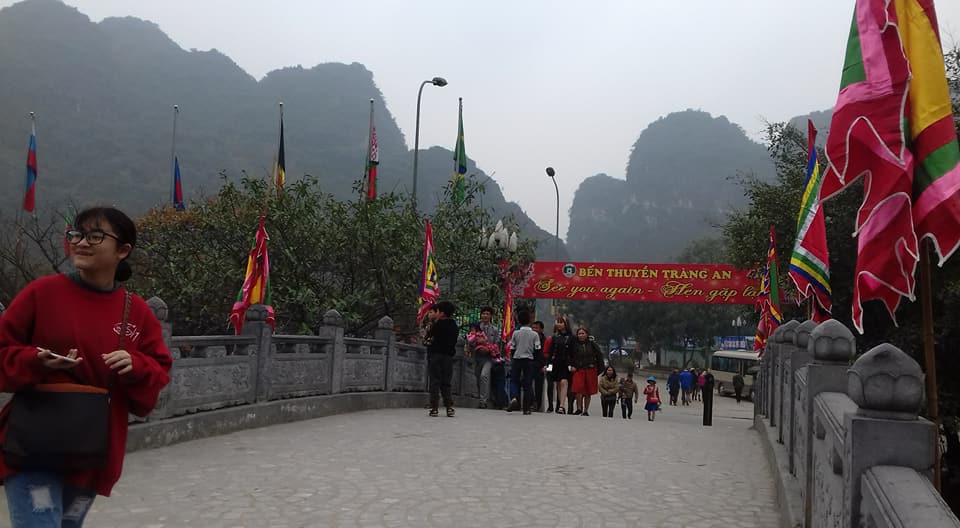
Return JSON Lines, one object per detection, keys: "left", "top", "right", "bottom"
{"left": 518, "top": 262, "right": 760, "bottom": 304}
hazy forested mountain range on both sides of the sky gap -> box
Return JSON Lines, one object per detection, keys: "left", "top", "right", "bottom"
{"left": 0, "top": 0, "right": 824, "bottom": 261}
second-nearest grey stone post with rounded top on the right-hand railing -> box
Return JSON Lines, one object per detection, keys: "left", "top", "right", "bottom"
{"left": 796, "top": 319, "right": 856, "bottom": 528}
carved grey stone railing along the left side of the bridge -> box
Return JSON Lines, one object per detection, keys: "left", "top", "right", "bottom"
{"left": 130, "top": 297, "right": 477, "bottom": 449}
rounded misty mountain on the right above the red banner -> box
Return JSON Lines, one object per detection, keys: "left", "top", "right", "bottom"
{"left": 568, "top": 110, "right": 774, "bottom": 262}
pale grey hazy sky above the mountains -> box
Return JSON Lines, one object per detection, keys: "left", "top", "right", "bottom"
{"left": 0, "top": 0, "right": 960, "bottom": 241}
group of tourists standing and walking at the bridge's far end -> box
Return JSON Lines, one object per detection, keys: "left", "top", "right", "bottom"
{"left": 425, "top": 302, "right": 660, "bottom": 421}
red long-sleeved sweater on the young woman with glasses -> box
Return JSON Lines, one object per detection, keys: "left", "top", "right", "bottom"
{"left": 0, "top": 275, "right": 173, "bottom": 496}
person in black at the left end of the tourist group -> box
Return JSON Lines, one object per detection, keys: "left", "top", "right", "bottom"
{"left": 425, "top": 301, "right": 460, "bottom": 418}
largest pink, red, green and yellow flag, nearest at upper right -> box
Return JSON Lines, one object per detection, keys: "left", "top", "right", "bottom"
{"left": 820, "top": 0, "right": 960, "bottom": 333}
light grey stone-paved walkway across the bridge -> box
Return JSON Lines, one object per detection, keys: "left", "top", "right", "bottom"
{"left": 0, "top": 398, "right": 779, "bottom": 528}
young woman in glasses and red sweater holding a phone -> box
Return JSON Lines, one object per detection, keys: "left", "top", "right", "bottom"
{"left": 0, "top": 208, "right": 172, "bottom": 528}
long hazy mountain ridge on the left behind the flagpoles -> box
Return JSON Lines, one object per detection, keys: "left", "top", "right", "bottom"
{"left": 0, "top": 0, "right": 552, "bottom": 254}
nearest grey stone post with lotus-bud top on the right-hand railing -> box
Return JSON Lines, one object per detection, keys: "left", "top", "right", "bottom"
{"left": 843, "top": 343, "right": 937, "bottom": 526}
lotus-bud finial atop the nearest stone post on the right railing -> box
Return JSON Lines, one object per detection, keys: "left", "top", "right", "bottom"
{"left": 847, "top": 343, "right": 923, "bottom": 420}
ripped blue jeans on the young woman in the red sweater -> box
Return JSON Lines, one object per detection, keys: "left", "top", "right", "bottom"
{"left": 3, "top": 471, "right": 97, "bottom": 528}
